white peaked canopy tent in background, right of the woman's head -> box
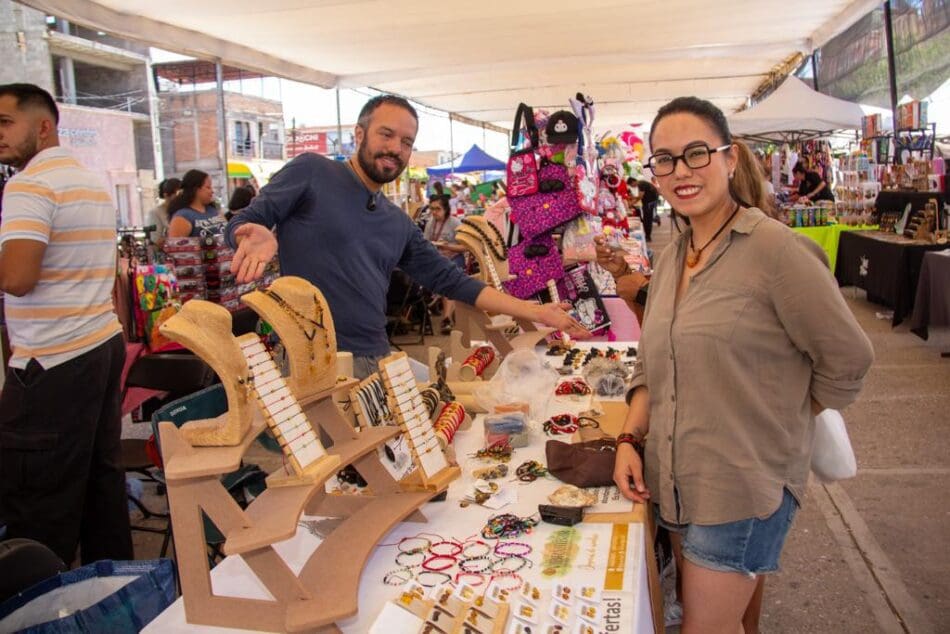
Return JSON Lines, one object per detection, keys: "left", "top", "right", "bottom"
{"left": 729, "top": 77, "right": 864, "bottom": 141}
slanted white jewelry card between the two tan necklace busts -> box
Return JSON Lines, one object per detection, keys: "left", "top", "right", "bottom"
{"left": 239, "top": 334, "right": 326, "bottom": 470}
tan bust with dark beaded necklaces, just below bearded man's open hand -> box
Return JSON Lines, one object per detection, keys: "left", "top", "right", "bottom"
{"left": 241, "top": 276, "right": 337, "bottom": 400}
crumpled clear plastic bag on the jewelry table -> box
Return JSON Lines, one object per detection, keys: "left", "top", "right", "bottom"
{"left": 475, "top": 348, "right": 559, "bottom": 420}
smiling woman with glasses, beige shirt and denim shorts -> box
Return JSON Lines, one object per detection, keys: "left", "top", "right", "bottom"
{"left": 614, "top": 97, "right": 873, "bottom": 634}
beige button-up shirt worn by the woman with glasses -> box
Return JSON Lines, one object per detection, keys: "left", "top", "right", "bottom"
{"left": 634, "top": 209, "right": 873, "bottom": 525}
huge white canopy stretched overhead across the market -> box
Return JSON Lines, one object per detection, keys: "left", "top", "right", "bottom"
{"left": 20, "top": 0, "right": 880, "bottom": 130}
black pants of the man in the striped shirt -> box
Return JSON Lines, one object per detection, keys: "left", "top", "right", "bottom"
{"left": 0, "top": 335, "right": 132, "bottom": 566}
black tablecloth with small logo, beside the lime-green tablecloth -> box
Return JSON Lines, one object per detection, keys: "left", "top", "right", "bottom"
{"left": 835, "top": 231, "right": 946, "bottom": 326}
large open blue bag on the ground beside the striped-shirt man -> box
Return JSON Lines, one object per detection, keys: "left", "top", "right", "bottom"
{"left": 0, "top": 559, "right": 175, "bottom": 634}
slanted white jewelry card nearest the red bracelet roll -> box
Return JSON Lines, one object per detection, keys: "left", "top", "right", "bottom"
{"left": 379, "top": 355, "right": 449, "bottom": 478}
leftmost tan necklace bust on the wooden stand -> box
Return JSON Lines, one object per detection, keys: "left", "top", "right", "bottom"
{"left": 159, "top": 300, "right": 256, "bottom": 447}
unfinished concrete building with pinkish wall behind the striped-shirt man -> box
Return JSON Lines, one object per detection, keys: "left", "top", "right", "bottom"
{"left": 0, "top": 0, "right": 161, "bottom": 225}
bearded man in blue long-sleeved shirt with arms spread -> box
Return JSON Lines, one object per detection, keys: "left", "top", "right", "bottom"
{"left": 226, "top": 95, "right": 587, "bottom": 376}
